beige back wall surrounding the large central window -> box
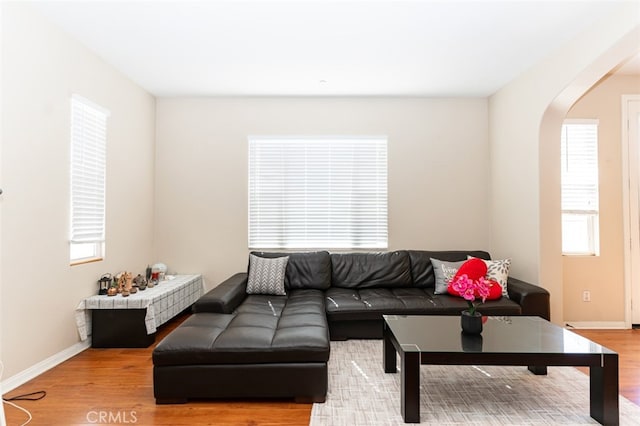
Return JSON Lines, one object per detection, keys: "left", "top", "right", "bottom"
{"left": 155, "top": 98, "right": 489, "bottom": 287}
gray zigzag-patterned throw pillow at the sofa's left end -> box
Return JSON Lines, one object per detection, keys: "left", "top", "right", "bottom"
{"left": 247, "top": 254, "right": 289, "bottom": 296}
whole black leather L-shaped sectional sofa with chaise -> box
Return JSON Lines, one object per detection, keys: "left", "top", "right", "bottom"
{"left": 153, "top": 250, "right": 550, "bottom": 403}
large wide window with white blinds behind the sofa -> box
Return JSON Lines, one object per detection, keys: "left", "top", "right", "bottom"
{"left": 249, "top": 137, "right": 387, "bottom": 249}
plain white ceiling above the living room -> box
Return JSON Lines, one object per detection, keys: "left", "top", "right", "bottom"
{"left": 34, "top": 0, "right": 640, "bottom": 97}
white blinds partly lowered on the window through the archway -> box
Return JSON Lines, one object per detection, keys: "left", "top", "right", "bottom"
{"left": 561, "top": 121, "right": 598, "bottom": 213}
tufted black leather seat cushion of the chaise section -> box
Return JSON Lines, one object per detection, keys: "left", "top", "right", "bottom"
{"left": 153, "top": 290, "right": 329, "bottom": 366}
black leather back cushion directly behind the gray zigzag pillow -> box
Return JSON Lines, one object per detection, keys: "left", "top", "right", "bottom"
{"left": 251, "top": 251, "right": 331, "bottom": 290}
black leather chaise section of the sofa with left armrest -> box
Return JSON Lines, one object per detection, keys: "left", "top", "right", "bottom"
{"left": 153, "top": 274, "right": 329, "bottom": 403}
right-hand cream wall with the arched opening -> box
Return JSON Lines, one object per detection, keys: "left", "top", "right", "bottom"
{"left": 489, "top": 2, "right": 640, "bottom": 322}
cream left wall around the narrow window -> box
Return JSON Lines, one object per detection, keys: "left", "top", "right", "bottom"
{"left": 0, "top": 2, "right": 155, "bottom": 380}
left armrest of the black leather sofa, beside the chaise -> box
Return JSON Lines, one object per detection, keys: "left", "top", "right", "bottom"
{"left": 191, "top": 273, "right": 247, "bottom": 314}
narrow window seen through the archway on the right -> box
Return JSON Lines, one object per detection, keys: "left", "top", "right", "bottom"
{"left": 561, "top": 120, "right": 600, "bottom": 256}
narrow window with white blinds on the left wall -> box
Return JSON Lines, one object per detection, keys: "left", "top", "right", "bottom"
{"left": 69, "top": 95, "right": 109, "bottom": 263}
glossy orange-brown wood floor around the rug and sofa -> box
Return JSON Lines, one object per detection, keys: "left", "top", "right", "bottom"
{"left": 4, "top": 315, "right": 640, "bottom": 426}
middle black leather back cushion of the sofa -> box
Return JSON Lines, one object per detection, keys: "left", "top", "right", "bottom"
{"left": 331, "top": 251, "right": 413, "bottom": 288}
